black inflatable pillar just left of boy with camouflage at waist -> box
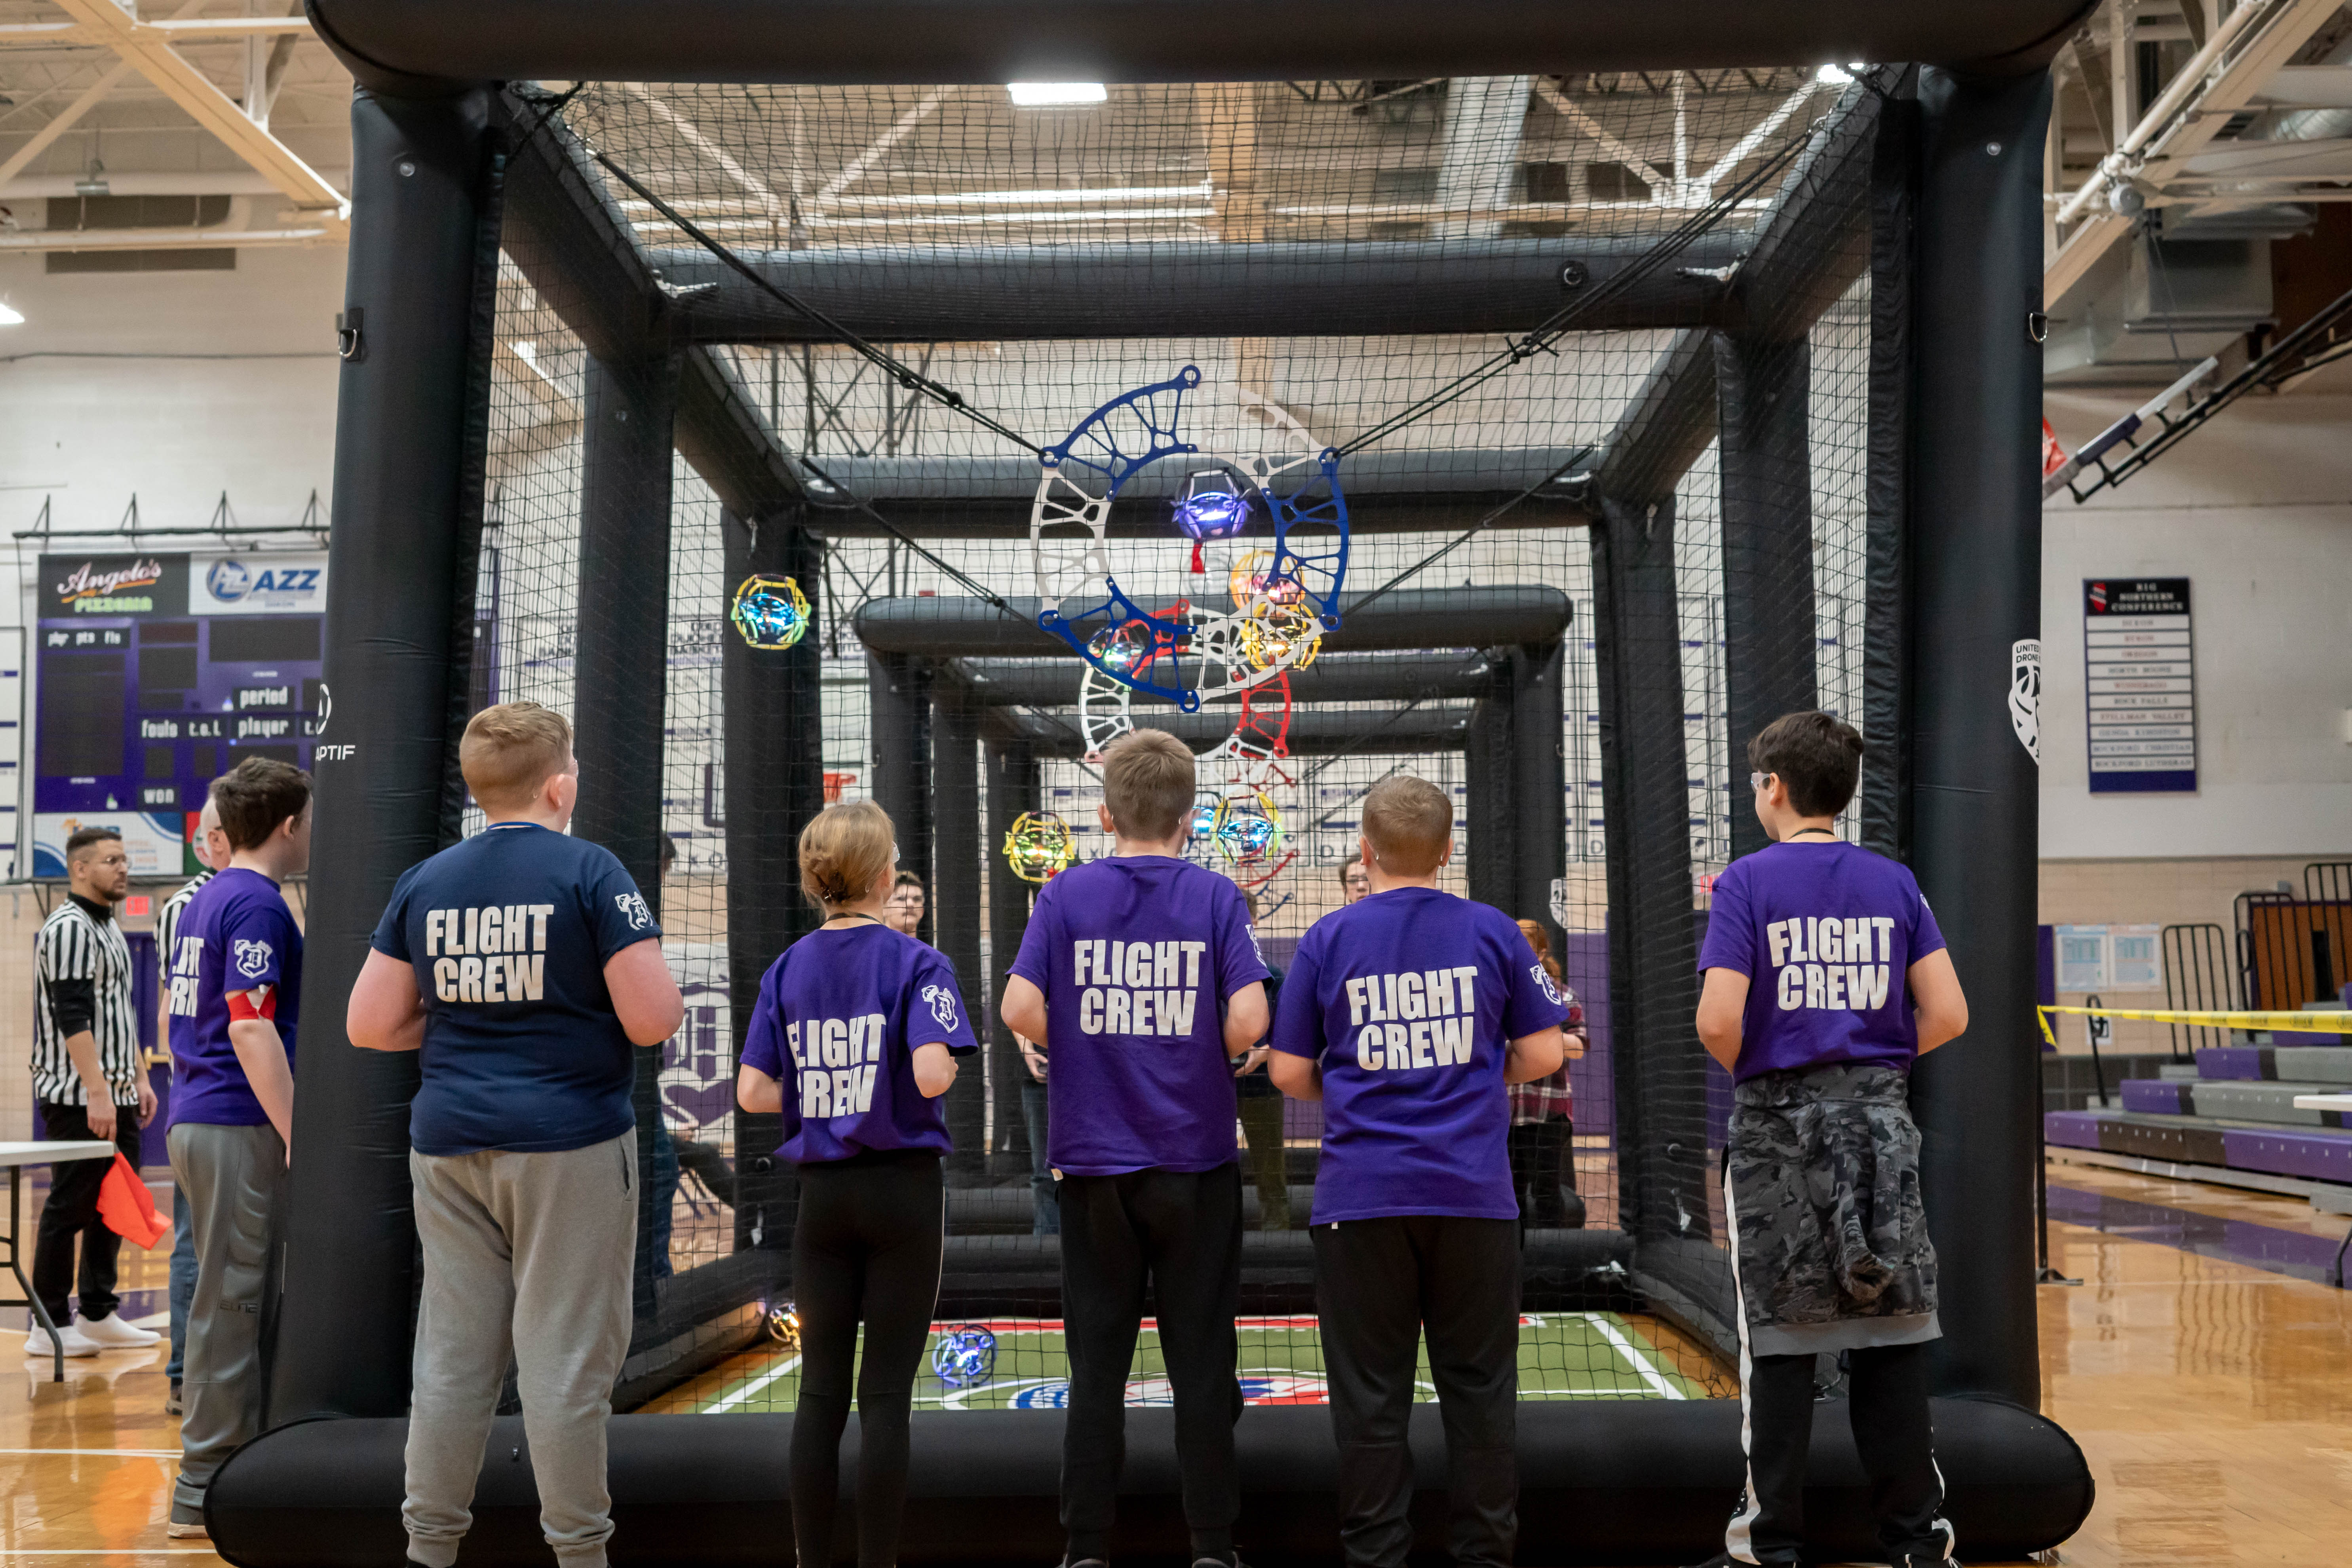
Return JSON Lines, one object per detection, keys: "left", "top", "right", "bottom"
{"left": 1592, "top": 496, "right": 1712, "bottom": 1251}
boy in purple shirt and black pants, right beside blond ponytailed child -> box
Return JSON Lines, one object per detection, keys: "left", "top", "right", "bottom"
{"left": 1002, "top": 729, "right": 1265, "bottom": 1568}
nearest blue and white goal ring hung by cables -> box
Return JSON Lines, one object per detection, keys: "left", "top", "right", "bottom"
{"left": 1030, "top": 364, "right": 1348, "bottom": 712}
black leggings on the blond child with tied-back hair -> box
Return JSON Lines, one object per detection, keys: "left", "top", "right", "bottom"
{"left": 793, "top": 1150, "right": 945, "bottom": 1568}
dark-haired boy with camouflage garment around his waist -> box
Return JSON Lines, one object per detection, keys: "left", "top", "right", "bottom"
{"left": 1698, "top": 712, "right": 1969, "bottom": 1568}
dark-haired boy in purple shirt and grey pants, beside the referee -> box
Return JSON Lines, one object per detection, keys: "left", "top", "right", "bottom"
{"left": 169, "top": 757, "right": 310, "bottom": 1538}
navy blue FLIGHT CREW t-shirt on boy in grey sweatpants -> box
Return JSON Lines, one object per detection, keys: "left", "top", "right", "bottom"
{"left": 374, "top": 823, "right": 661, "bottom": 1154}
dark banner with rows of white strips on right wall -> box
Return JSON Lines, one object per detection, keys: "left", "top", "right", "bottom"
{"left": 2082, "top": 576, "right": 2197, "bottom": 794}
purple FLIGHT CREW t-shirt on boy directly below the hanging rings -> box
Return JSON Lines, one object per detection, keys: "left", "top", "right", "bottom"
{"left": 1014, "top": 856, "right": 1270, "bottom": 1175}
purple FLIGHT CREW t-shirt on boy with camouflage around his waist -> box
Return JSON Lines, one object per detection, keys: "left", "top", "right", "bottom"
{"left": 1698, "top": 842, "right": 1943, "bottom": 1081}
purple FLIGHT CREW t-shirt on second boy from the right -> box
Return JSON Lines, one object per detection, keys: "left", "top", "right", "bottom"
{"left": 1279, "top": 889, "right": 1569, "bottom": 1225}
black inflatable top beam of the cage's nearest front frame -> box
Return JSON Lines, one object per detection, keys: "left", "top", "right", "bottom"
{"left": 308, "top": 0, "right": 2091, "bottom": 94}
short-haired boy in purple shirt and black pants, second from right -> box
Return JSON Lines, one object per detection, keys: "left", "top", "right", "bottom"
{"left": 1272, "top": 774, "right": 1569, "bottom": 1568}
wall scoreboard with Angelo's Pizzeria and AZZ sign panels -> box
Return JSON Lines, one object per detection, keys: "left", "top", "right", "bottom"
{"left": 33, "top": 553, "right": 327, "bottom": 877}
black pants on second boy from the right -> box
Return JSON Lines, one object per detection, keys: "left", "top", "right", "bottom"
{"left": 1315, "top": 1215, "right": 1519, "bottom": 1568}
